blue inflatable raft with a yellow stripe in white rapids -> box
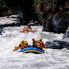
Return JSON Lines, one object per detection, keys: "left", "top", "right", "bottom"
{"left": 19, "top": 47, "right": 45, "bottom": 54}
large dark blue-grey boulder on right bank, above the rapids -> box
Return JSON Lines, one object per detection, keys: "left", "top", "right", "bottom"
{"left": 52, "top": 13, "right": 69, "bottom": 33}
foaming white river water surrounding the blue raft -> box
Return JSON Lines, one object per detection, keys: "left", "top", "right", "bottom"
{"left": 0, "top": 27, "right": 69, "bottom": 69}
